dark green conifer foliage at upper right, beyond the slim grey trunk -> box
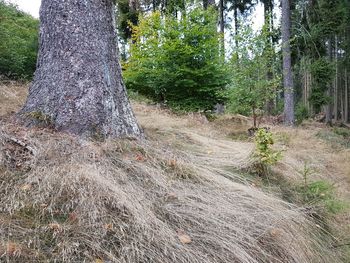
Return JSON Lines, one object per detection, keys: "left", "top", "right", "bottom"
{"left": 293, "top": 0, "right": 350, "bottom": 113}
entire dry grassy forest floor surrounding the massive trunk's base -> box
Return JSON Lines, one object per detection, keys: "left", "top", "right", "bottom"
{"left": 0, "top": 82, "right": 350, "bottom": 263}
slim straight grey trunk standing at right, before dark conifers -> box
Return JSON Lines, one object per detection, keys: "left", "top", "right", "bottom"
{"left": 282, "top": 0, "right": 294, "bottom": 125}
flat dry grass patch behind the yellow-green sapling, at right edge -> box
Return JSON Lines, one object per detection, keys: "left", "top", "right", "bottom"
{"left": 274, "top": 126, "right": 350, "bottom": 198}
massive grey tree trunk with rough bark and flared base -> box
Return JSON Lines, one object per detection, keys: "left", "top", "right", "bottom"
{"left": 21, "top": 0, "right": 142, "bottom": 137}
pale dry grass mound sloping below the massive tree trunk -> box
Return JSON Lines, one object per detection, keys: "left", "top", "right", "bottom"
{"left": 0, "top": 84, "right": 340, "bottom": 263}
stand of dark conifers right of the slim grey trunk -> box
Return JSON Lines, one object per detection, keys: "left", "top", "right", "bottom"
{"left": 293, "top": 0, "right": 350, "bottom": 123}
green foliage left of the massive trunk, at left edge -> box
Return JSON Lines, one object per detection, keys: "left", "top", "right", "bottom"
{"left": 0, "top": 0, "right": 39, "bottom": 78}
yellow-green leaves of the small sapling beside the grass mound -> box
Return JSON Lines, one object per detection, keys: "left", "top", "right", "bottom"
{"left": 255, "top": 129, "right": 282, "bottom": 166}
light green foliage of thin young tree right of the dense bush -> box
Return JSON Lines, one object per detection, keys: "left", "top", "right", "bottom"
{"left": 228, "top": 23, "right": 280, "bottom": 124}
